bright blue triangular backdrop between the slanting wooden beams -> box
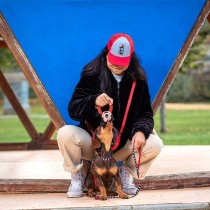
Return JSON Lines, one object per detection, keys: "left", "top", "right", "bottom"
{"left": 0, "top": 0, "right": 205, "bottom": 123}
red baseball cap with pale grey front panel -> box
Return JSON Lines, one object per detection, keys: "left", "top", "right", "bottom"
{"left": 107, "top": 33, "right": 134, "bottom": 66}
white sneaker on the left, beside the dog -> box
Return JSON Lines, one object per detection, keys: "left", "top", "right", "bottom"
{"left": 67, "top": 171, "right": 85, "bottom": 198}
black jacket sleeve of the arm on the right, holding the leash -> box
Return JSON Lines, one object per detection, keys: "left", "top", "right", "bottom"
{"left": 130, "top": 82, "right": 154, "bottom": 139}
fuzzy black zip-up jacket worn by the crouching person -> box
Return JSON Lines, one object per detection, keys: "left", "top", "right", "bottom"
{"left": 68, "top": 71, "right": 154, "bottom": 149}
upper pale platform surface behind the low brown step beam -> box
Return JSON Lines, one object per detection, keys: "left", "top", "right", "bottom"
{"left": 0, "top": 146, "right": 210, "bottom": 180}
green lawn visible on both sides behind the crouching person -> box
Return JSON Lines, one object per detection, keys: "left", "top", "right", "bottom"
{"left": 0, "top": 103, "right": 210, "bottom": 145}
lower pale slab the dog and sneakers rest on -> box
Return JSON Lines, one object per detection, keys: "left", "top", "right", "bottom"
{"left": 0, "top": 187, "right": 210, "bottom": 210}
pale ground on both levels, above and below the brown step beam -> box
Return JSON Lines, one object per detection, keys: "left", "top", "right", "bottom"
{"left": 0, "top": 146, "right": 210, "bottom": 210}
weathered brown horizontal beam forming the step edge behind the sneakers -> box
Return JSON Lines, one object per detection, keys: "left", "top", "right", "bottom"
{"left": 0, "top": 171, "right": 210, "bottom": 193}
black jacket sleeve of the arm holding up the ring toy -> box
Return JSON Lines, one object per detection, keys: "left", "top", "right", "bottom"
{"left": 68, "top": 76, "right": 99, "bottom": 121}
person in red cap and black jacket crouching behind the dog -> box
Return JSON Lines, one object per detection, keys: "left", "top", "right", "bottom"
{"left": 57, "top": 34, "right": 162, "bottom": 197}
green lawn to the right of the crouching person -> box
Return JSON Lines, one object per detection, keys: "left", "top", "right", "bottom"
{"left": 155, "top": 110, "right": 210, "bottom": 145}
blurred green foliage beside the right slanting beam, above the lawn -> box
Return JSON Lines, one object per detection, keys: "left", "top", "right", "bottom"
{"left": 166, "top": 21, "right": 210, "bottom": 102}
